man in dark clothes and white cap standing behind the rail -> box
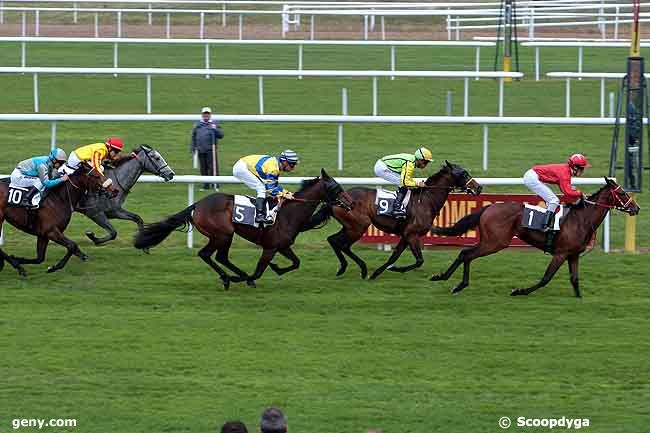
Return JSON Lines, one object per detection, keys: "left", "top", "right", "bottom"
{"left": 190, "top": 107, "right": 223, "bottom": 190}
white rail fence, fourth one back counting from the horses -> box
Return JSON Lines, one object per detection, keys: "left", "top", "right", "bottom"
{"left": 0, "top": 36, "right": 496, "bottom": 76}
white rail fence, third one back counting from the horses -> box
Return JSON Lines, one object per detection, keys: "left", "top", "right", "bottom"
{"left": 0, "top": 67, "right": 524, "bottom": 116}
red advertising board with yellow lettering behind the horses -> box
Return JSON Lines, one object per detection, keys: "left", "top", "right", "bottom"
{"left": 361, "top": 194, "right": 545, "bottom": 246}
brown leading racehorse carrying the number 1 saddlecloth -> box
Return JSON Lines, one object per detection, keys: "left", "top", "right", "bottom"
{"left": 431, "top": 178, "right": 639, "bottom": 297}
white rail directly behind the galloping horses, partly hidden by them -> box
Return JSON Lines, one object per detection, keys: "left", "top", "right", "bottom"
{"left": 0, "top": 175, "right": 610, "bottom": 252}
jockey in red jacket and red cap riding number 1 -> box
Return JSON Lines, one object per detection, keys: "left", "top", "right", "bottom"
{"left": 524, "top": 153, "right": 589, "bottom": 252}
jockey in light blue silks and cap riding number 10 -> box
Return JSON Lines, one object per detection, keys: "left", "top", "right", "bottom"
{"left": 11, "top": 148, "right": 68, "bottom": 204}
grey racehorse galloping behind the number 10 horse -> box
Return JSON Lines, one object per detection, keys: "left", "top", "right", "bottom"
{"left": 75, "top": 144, "right": 174, "bottom": 245}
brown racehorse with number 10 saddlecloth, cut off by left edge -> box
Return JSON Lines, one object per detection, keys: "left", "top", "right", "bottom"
{"left": 0, "top": 163, "right": 106, "bottom": 276}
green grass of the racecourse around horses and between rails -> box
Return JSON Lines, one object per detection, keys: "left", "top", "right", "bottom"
{"left": 0, "top": 44, "right": 650, "bottom": 433}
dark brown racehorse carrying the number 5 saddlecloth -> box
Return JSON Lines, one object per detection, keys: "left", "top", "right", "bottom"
{"left": 135, "top": 170, "right": 351, "bottom": 290}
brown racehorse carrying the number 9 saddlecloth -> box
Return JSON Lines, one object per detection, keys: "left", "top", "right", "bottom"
{"left": 304, "top": 161, "right": 482, "bottom": 280}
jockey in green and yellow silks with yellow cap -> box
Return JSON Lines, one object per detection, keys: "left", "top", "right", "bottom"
{"left": 375, "top": 147, "right": 433, "bottom": 219}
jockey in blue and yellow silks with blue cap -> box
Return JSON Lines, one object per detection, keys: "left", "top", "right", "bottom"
{"left": 232, "top": 150, "right": 298, "bottom": 224}
